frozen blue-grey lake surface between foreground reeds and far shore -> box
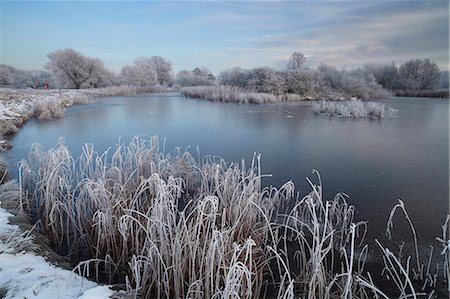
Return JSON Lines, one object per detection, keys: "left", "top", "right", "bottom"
{"left": 5, "top": 93, "right": 449, "bottom": 253}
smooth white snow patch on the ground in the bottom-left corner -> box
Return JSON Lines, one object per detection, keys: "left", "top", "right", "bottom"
{"left": 0, "top": 208, "right": 114, "bottom": 299}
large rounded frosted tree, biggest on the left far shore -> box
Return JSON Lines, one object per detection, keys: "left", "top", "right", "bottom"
{"left": 45, "top": 49, "right": 112, "bottom": 89}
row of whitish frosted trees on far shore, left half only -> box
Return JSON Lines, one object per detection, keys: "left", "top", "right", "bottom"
{"left": 0, "top": 49, "right": 215, "bottom": 89}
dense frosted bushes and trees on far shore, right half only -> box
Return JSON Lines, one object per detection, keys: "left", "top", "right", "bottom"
{"left": 218, "top": 52, "right": 449, "bottom": 99}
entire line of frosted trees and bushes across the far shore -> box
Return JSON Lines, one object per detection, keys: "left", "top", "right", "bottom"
{"left": 0, "top": 49, "right": 449, "bottom": 99}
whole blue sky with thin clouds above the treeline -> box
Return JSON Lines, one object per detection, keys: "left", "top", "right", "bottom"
{"left": 0, "top": 0, "right": 449, "bottom": 74}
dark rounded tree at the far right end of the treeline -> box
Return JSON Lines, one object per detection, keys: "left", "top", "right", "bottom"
{"left": 399, "top": 59, "right": 440, "bottom": 91}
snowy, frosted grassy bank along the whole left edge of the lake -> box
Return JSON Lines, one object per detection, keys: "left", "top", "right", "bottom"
{"left": 0, "top": 86, "right": 171, "bottom": 299}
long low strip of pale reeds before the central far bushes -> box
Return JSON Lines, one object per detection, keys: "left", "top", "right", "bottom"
{"left": 180, "top": 86, "right": 279, "bottom": 104}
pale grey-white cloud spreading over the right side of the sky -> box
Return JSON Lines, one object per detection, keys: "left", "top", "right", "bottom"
{"left": 223, "top": 2, "right": 449, "bottom": 67}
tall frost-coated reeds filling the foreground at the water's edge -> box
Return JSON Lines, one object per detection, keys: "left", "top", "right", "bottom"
{"left": 19, "top": 137, "right": 448, "bottom": 299}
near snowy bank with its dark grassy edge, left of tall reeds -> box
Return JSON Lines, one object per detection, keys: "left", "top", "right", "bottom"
{"left": 0, "top": 182, "right": 115, "bottom": 299}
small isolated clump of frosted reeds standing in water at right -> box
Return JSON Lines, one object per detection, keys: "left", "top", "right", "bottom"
{"left": 313, "top": 100, "right": 398, "bottom": 119}
